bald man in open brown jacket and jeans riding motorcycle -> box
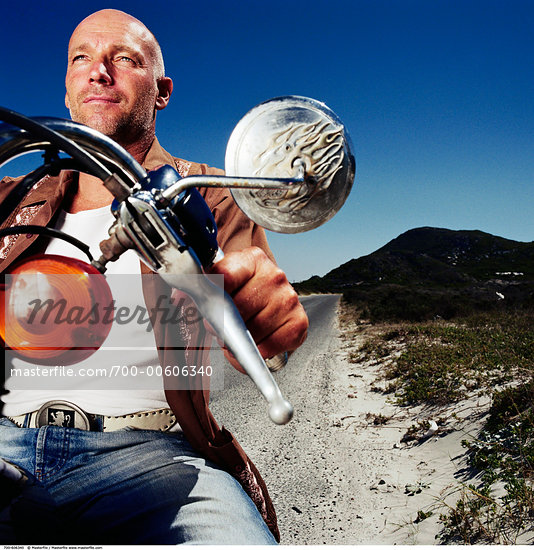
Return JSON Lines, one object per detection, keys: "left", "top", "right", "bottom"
{"left": 0, "top": 10, "right": 307, "bottom": 544}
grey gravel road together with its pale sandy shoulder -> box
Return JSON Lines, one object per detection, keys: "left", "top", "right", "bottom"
{"left": 213, "top": 296, "right": 492, "bottom": 544}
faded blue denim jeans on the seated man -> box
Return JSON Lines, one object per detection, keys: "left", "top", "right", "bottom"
{"left": 0, "top": 418, "right": 275, "bottom": 545}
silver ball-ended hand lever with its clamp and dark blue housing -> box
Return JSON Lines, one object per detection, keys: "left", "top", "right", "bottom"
{"left": 97, "top": 165, "right": 293, "bottom": 424}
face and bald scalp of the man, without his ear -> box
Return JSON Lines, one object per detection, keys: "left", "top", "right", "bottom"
{"left": 65, "top": 12, "right": 162, "bottom": 146}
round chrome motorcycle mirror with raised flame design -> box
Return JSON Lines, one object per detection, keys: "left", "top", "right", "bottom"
{"left": 225, "top": 96, "right": 355, "bottom": 233}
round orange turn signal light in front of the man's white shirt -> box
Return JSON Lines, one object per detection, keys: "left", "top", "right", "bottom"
{"left": 0, "top": 254, "right": 114, "bottom": 365}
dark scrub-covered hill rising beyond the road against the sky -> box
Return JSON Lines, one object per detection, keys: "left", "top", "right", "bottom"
{"left": 295, "top": 227, "right": 534, "bottom": 320}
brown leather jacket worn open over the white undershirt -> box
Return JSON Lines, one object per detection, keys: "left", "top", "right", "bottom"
{"left": 0, "top": 139, "right": 280, "bottom": 541}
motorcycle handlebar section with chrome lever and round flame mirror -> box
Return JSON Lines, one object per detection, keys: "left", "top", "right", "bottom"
{"left": 0, "top": 96, "right": 355, "bottom": 424}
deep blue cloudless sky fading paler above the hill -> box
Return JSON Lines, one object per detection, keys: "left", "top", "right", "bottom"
{"left": 0, "top": 0, "right": 534, "bottom": 281}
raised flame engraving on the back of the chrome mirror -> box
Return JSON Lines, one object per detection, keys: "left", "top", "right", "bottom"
{"left": 254, "top": 120, "right": 344, "bottom": 212}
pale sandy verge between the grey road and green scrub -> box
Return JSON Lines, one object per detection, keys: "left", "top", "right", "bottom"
{"left": 332, "top": 320, "right": 487, "bottom": 544}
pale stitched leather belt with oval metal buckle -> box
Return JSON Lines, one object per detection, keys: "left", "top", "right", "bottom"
{"left": 6, "top": 401, "right": 177, "bottom": 432}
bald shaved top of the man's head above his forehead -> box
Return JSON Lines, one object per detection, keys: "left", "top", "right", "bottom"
{"left": 69, "top": 9, "right": 165, "bottom": 78}
